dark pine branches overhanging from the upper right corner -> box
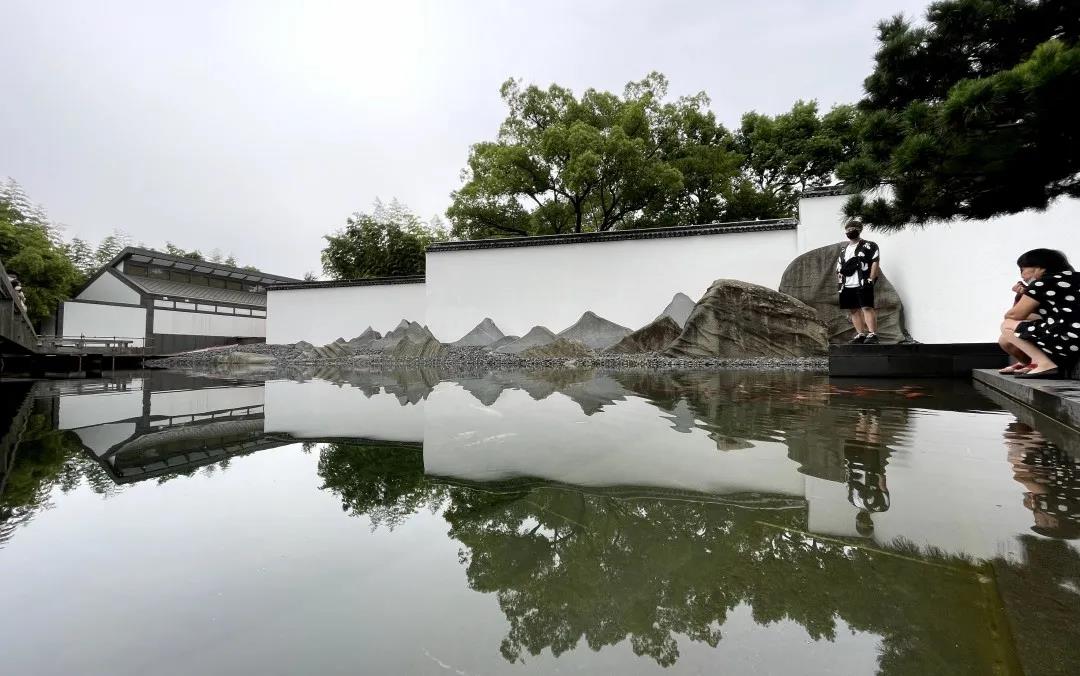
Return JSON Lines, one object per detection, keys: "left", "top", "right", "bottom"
{"left": 838, "top": 0, "right": 1080, "bottom": 227}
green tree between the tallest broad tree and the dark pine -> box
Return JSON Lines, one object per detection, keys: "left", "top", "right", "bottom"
{"left": 735, "top": 100, "right": 856, "bottom": 217}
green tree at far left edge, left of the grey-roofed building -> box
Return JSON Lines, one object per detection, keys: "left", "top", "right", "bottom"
{"left": 0, "top": 185, "right": 82, "bottom": 324}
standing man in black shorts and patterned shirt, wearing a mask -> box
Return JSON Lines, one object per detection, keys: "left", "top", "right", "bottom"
{"left": 836, "top": 219, "right": 881, "bottom": 344}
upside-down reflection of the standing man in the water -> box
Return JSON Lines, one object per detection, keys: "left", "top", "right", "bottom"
{"left": 843, "top": 408, "right": 889, "bottom": 537}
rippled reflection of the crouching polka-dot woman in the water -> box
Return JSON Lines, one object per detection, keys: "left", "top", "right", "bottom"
{"left": 1004, "top": 421, "right": 1080, "bottom": 540}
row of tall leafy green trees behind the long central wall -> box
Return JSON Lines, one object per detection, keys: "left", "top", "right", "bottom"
{"left": 447, "top": 72, "right": 854, "bottom": 239}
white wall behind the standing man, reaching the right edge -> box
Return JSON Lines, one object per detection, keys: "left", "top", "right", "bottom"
{"left": 798, "top": 195, "right": 1080, "bottom": 342}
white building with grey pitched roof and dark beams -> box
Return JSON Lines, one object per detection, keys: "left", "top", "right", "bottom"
{"left": 57, "top": 247, "right": 298, "bottom": 354}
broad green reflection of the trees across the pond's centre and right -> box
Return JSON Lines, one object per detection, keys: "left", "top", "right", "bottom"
{"left": 319, "top": 444, "right": 994, "bottom": 674}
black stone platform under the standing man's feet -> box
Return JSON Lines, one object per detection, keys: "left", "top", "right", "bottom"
{"left": 828, "top": 342, "right": 1008, "bottom": 378}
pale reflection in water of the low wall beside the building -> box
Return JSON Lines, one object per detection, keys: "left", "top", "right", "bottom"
{"left": 262, "top": 380, "right": 426, "bottom": 443}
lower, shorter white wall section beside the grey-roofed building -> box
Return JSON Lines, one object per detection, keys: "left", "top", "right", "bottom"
{"left": 267, "top": 284, "right": 425, "bottom": 344}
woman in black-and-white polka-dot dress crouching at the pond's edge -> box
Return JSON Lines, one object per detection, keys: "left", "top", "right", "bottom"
{"left": 999, "top": 248, "right": 1080, "bottom": 378}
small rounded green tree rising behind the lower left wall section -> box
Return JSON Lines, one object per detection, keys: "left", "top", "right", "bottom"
{"left": 322, "top": 200, "right": 446, "bottom": 280}
